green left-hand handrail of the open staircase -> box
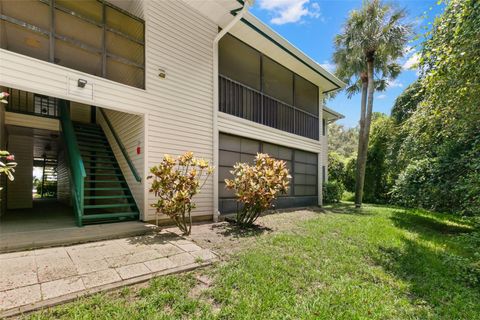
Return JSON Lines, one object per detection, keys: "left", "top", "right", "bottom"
{"left": 59, "top": 100, "right": 87, "bottom": 227}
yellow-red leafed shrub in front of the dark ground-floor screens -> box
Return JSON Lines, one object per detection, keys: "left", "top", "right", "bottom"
{"left": 225, "top": 153, "right": 291, "bottom": 225}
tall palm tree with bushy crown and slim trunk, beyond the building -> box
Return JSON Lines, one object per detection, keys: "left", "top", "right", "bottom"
{"left": 333, "top": 0, "right": 411, "bottom": 207}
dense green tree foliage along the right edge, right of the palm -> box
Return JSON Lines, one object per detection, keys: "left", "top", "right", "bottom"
{"left": 395, "top": 0, "right": 480, "bottom": 214}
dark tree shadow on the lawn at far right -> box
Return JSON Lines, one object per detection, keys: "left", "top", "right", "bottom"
{"left": 373, "top": 210, "right": 480, "bottom": 319}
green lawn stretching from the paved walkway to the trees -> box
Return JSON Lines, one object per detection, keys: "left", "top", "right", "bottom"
{"left": 27, "top": 204, "right": 480, "bottom": 319}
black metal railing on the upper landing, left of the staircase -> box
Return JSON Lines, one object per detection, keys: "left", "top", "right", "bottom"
{"left": 7, "top": 89, "right": 60, "bottom": 118}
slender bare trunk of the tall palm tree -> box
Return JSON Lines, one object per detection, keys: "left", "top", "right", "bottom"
{"left": 355, "top": 54, "right": 375, "bottom": 208}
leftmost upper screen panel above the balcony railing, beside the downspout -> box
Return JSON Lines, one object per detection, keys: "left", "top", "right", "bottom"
{"left": 218, "top": 34, "right": 260, "bottom": 90}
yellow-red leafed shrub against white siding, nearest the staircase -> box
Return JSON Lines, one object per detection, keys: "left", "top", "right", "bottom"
{"left": 148, "top": 152, "right": 213, "bottom": 235}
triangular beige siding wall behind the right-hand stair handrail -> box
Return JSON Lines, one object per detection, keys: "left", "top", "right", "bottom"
{"left": 97, "top": 109, "right": 145, "bottom": 218}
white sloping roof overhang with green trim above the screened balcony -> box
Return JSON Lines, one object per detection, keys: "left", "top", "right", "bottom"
{"left": 184, "top": 0, "right": 345, "bottom": 93}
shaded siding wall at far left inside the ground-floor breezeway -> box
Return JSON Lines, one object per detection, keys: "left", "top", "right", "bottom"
{"left": 7, "top": 135, "right": 33, "bottom": 209}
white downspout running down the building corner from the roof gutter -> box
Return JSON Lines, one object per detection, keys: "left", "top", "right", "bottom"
{"left": 212, "top": 0, "right": 253, "bottom": 222}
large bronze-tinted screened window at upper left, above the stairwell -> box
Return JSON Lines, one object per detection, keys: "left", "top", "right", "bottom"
{"left": 0, "top": 0, "right": 145, "bottom": 88}
